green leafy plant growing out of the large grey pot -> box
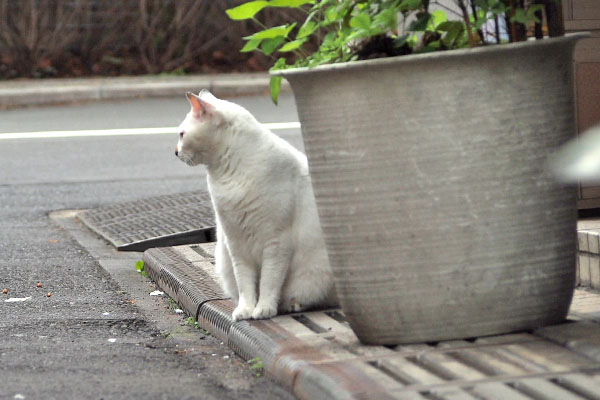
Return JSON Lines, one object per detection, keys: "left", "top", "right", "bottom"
{"left": 227, "top": 0, "right": 564, "bottom": 102}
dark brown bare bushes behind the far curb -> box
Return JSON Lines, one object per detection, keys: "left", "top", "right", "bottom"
{"left": 0, "top": 0, "right": 289, "bottom": 79}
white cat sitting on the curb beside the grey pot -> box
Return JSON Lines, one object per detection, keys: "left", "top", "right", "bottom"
{"left": 175, "top": 91, "right": 337, "bottom": 321}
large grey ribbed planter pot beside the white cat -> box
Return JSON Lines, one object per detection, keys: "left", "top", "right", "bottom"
{"left": 278, "top": 35, "right": 582, "bottom": 344}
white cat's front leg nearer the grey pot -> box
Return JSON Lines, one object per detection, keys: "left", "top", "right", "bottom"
{"left": 252, "top": 242, "right": 291, "bottom": 319}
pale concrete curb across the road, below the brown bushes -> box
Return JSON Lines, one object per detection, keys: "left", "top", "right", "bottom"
{"left": 0, "top": 72, "right": 289, "bottom": 108}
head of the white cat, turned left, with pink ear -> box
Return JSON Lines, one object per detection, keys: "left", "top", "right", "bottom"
{"left": 175, "top": 90, "right": 229, "bottom": 166}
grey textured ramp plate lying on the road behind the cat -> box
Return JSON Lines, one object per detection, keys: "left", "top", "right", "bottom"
{"left": 79, "top": 191, "right": 215, "bottom": 251}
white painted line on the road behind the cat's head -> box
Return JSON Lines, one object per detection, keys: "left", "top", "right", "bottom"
{"left": 0, "top": 122, "right": 300, "bottom": 140}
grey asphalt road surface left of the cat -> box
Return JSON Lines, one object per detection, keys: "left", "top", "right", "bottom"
{"left": 0, "top": 96, "right": 301, "bottom": 400}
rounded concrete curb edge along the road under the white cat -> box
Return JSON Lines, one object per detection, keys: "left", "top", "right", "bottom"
{"left": 143, "top": 244, "right": 391, "bottom": 400}
